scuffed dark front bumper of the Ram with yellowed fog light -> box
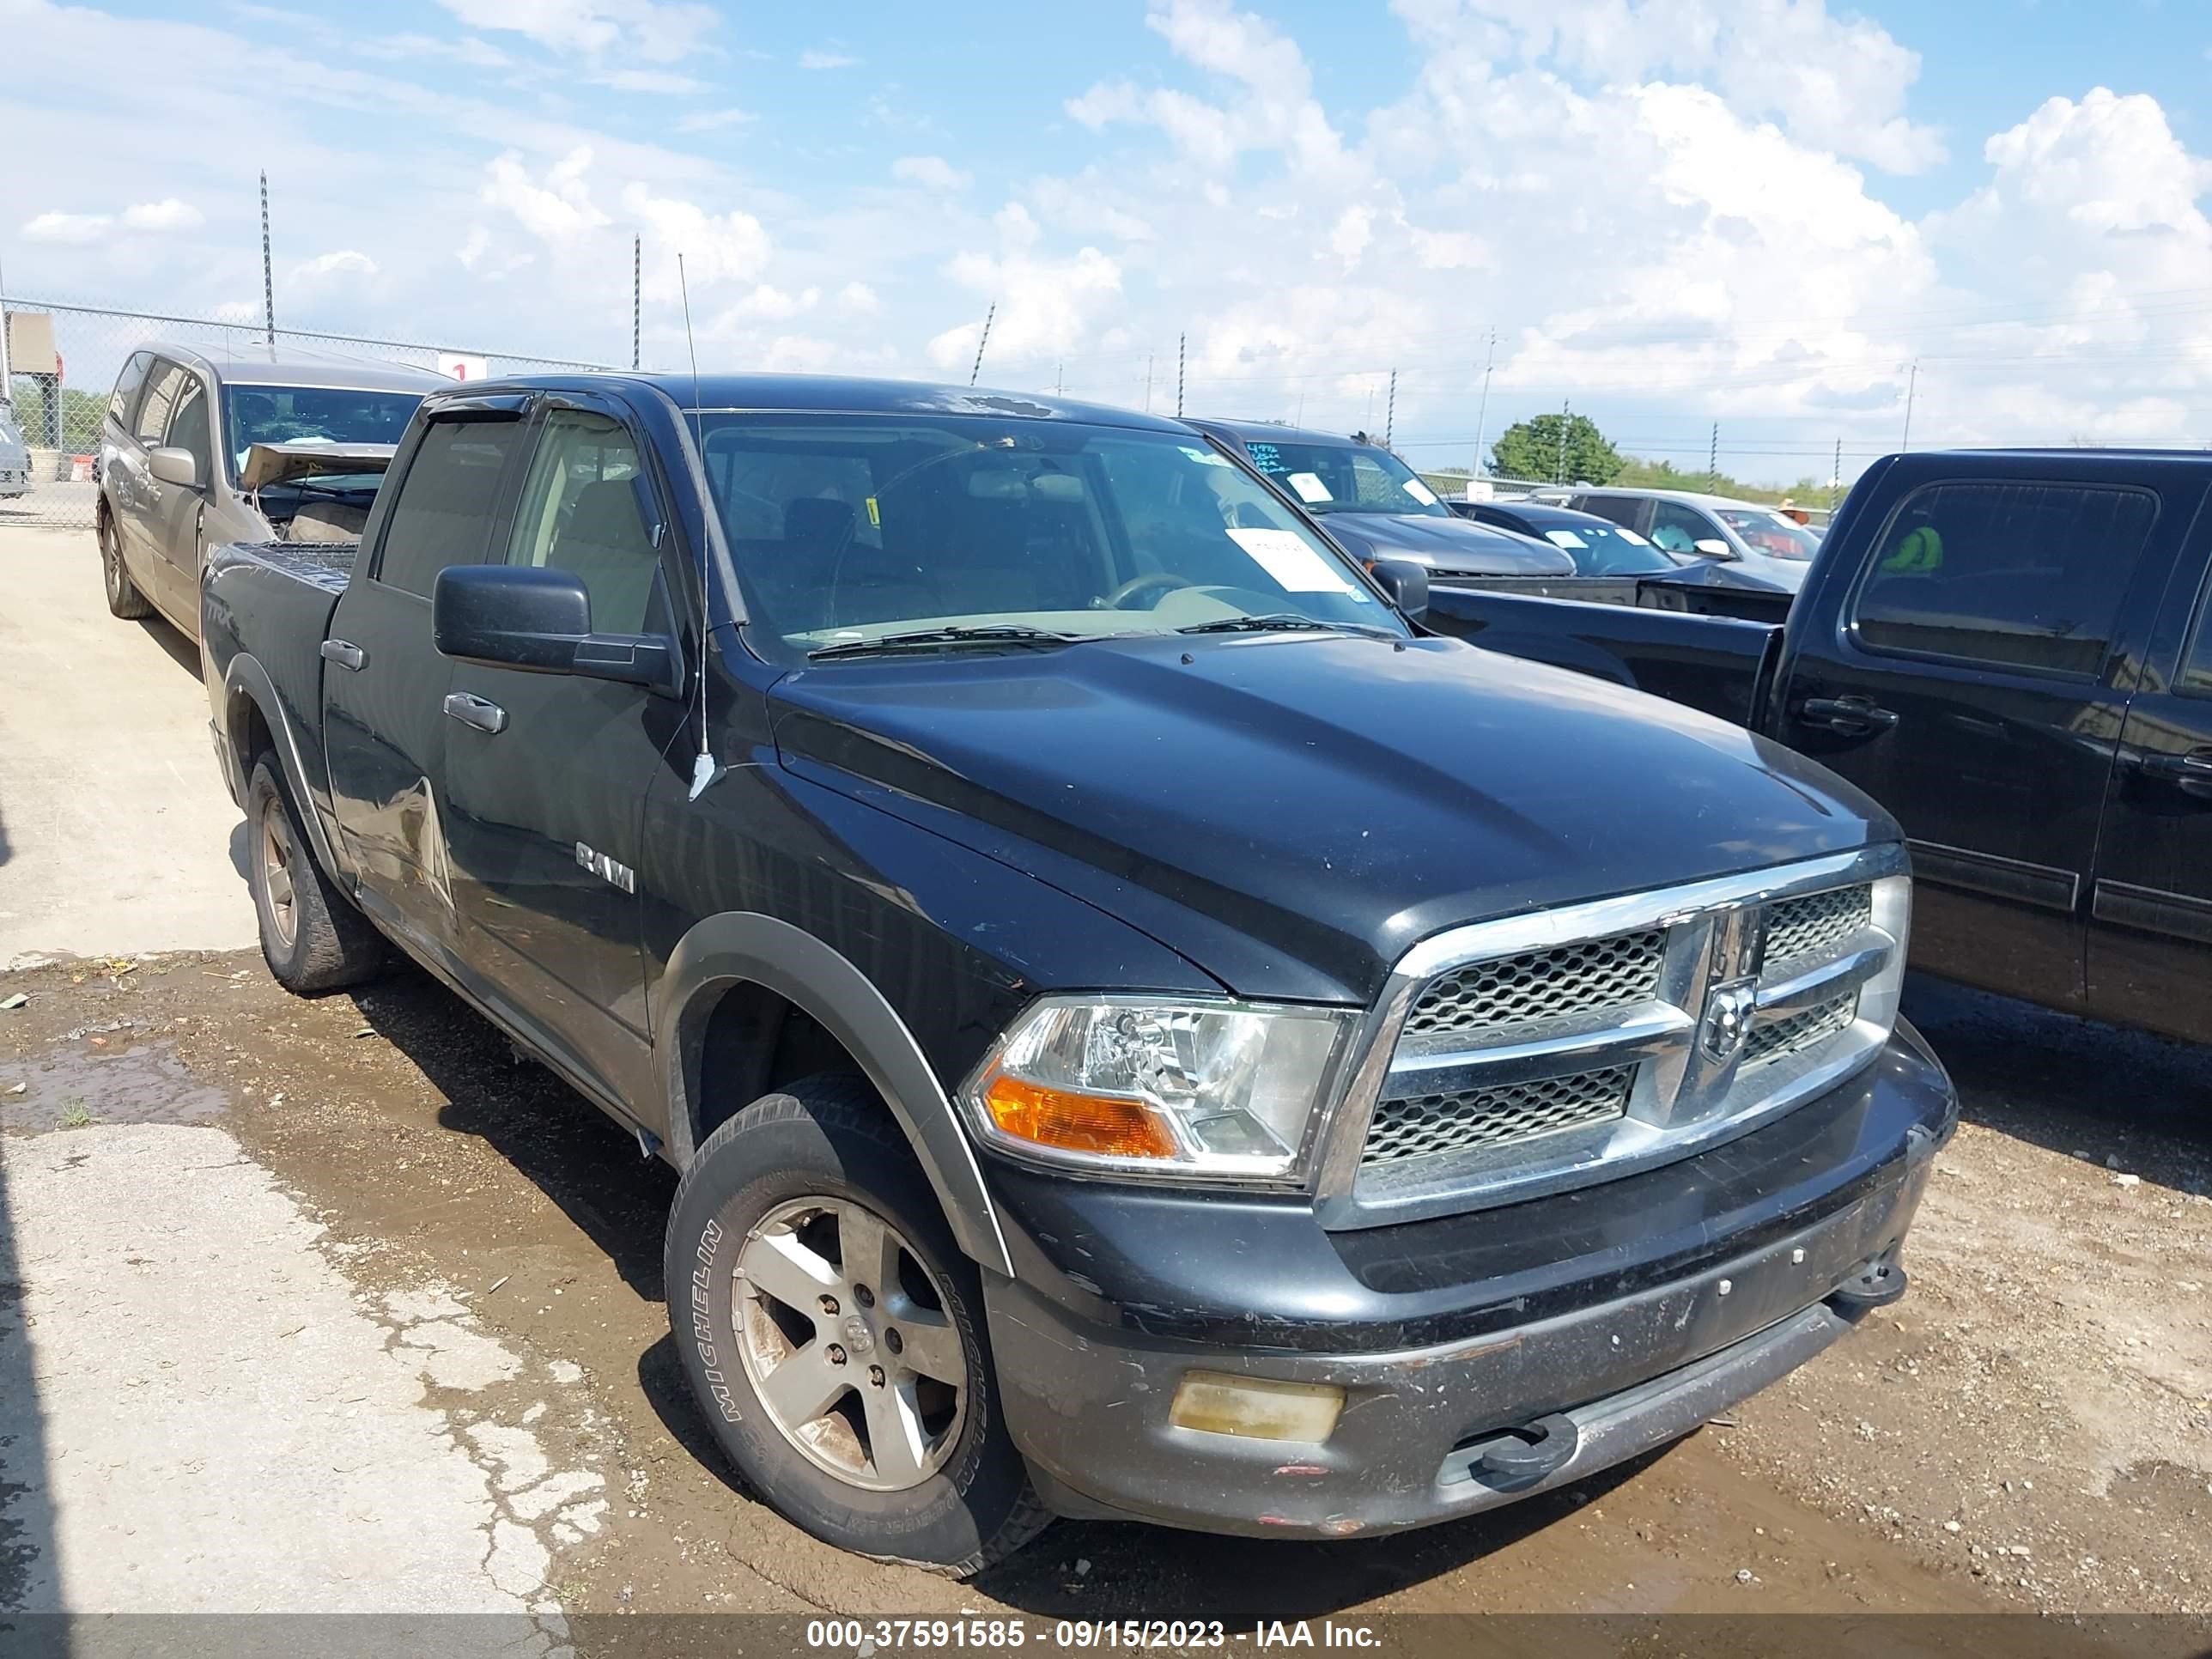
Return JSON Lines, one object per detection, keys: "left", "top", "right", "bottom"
{"left": 987, "top": 1026, "right": 1958, "bottom": 1537}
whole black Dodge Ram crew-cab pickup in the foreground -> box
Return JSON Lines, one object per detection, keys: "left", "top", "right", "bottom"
{"left": 201, "top": 376, "right": 1955, "bottom": 1571}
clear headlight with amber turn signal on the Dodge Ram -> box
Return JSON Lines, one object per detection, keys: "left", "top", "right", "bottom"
{"left": 963, "top": 995, "right": 1356, "bottom": 1182}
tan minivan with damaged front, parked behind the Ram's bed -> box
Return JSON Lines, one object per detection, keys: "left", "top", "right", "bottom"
{"left": 93, "top": 343, "right": 452, "bottom": 639}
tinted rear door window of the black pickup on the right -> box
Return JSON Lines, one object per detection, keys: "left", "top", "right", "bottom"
{"left": 1851, "top": 480, "right": 2159, "bottom": 679}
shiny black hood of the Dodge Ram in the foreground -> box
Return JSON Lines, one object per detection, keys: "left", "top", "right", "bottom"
{"left": 769, "top": 635, "right": 1898, "bottom": 1002}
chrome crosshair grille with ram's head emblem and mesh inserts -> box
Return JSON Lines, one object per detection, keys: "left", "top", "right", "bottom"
{"left": 1321, "top": 848, "right": 1909, "bottom": 1225}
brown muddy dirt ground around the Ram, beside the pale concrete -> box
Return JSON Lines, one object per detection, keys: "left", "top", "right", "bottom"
{"left": 0, "top": 951, "right": 2212, "bottom": 1626}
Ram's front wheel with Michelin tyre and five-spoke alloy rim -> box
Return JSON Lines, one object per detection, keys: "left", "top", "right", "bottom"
{"left": 665, "top": 1075, "right": 1048, "bottom": 1577}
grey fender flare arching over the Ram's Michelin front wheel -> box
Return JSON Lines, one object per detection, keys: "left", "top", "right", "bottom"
{"left": 653, "top": 911, "right": 1013, "bottom": 1279}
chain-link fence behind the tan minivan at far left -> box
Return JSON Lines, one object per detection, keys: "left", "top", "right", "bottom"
{"left": 0, "top": 296, "right": 611, "bottom": 529}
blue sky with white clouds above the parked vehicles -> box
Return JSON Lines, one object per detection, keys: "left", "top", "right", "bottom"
{"left": 0, "top": 0, "right": 2212, "bottom": 480}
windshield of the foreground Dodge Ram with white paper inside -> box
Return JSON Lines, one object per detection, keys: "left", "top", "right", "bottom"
{"left": 699, "top": 414, "right": 1407, "bottom": 657}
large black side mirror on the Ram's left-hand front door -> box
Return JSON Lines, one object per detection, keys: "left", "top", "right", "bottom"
{"left": 429, "top": 564, "right": 679, "bottom": 692}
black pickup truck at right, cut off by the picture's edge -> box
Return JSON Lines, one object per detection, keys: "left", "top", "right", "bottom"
{"left": 1431, "top": 449, "right": 2212, "bottom": 1042}
